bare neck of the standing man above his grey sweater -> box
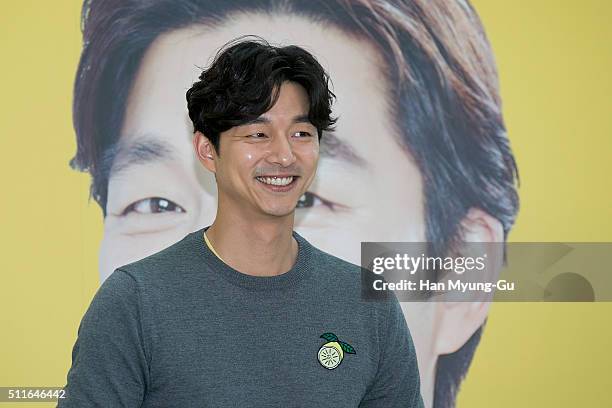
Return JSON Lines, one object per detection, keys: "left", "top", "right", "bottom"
{"left": 206, "top": 207, "right": 298, "bottom": 276}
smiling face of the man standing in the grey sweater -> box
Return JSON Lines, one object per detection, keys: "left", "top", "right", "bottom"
{"left": 207, "top": 82, "right": 319, "bottom": 219}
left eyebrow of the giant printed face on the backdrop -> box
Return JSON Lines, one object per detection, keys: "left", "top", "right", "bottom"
{"left": 102, "top": 136, "right": 176, "bottom": 178}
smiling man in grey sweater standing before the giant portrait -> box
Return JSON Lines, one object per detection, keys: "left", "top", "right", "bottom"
{"left": 60, "top": 39, "right": 423, "bottom": 407}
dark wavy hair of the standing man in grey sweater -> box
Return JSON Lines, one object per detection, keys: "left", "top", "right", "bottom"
{"left": 186, "top": 35, "right": 337, "bottom": 154}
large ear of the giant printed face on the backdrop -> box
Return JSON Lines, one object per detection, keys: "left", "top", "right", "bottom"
{"left": 434, "top": 208, "right": 504, "bottom": 354}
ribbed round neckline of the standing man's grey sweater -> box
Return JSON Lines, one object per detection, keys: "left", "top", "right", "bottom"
{"left": 191, "top": 226, "right": 312, "bottom": 290}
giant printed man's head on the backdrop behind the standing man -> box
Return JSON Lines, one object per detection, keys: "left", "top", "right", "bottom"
{"left": 72, "top": 0, "right": 518, "bottom": 406}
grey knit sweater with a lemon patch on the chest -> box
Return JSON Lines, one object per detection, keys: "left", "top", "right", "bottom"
{"left": 58, "top": 228, "right": 423, "bottom": 408}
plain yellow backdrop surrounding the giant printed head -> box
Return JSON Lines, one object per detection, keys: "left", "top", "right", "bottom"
{"left": 0, "top": 0, "right": 612, "bottom": 408}
